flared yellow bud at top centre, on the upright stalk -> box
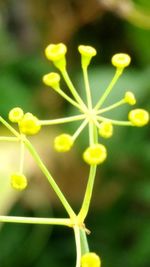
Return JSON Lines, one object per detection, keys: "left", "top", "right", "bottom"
{"left": 78, "top": 45, "right": 97, "bottom": 68}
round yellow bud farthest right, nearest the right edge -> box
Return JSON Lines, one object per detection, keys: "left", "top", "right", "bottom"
{"left": 128, "top": 108, "right": 149, "bottom": 127}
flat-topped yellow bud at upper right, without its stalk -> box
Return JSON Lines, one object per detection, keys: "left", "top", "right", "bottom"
{"left": 111, "top": 53, "right": 131, "bottom": 69}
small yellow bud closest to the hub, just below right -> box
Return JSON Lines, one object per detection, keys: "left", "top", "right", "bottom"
{"left": 99, "top": 121, "right": 113, "bottom": 138}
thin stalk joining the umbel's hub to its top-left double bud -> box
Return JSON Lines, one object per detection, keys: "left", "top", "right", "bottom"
{"left": 61, "top": 69, "right": 87, "bottom": 112}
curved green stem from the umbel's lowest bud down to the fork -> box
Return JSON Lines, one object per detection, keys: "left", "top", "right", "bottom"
{"left": 78, "top": 165, "right": 97, "bottom": 222}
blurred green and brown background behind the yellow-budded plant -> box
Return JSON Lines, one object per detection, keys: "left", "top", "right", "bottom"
{"left": 0, "top": 0, "right": 150, "bottom": 267}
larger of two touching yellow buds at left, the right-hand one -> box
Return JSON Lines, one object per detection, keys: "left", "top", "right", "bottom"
{"left": 19, "top": 112, "right": 41, "bottom": 135}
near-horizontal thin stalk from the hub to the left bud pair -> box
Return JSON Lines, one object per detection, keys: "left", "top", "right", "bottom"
{"left": 40, "top": 114, "right": 86, "bottom": 125}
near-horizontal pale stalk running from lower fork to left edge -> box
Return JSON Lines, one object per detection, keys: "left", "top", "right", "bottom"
{"left": 0, "top": 216, "right": 71, "bottom": 227}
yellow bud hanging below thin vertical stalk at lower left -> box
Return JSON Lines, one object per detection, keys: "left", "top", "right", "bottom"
{"left": 10, "top": 172, "right": 28, "bottom": 191}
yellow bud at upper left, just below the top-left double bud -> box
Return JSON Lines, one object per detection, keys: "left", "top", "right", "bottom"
{"left": 43, "top": 72, "right": 60, "bottom": 90}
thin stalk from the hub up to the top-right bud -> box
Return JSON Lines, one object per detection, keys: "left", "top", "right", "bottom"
{"left": 94, "top": 69, "right": 122, "bottom": 110}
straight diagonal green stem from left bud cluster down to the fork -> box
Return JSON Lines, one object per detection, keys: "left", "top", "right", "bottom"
{"left": 24, "top": 138, "right": 76, "bottom": 219}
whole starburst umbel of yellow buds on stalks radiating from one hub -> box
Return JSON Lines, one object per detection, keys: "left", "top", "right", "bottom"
{"left": 40, "top": 43, "right": 149, "bottom": 165}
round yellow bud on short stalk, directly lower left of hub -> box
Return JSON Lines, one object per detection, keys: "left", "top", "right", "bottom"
{"left": 54, "top": 134, "right": 73, "bottom": 152}
